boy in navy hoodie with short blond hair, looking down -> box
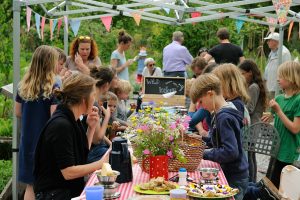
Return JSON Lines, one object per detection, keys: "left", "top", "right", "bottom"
{"left": 190, "top": 74, "right": 248, "bottom": 200}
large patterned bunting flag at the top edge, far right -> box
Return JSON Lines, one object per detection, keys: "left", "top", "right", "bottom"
{"left": 272, "top": 0, "right": 292, "bottom": 24}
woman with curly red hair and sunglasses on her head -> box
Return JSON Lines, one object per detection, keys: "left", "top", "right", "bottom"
{"left": 66, "top": 36, "right": 102, "bottom": 74}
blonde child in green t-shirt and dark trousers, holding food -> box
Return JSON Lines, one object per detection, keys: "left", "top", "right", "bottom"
{"left": 262, "top": 62, "right": 300, "bottom": 188}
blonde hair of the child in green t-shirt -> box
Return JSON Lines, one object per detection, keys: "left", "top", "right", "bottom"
{"left": 278, "top": 61, "right": 300, "bottom": 93}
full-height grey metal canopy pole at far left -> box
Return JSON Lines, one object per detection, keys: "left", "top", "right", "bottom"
{"left": 12, "top": 0, "right": 21, "bottom": 200}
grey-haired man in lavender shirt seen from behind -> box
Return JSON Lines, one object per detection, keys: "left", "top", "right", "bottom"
{"left": 163, "top": 31, "right": 193, "bottom": 77}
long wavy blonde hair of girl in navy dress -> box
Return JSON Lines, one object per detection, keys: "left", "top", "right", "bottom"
{"left": 18, "top": 45, "right": 59, "bottom": 101}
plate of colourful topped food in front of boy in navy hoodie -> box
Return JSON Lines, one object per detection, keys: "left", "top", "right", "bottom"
{"left": 186, "top": 183, "right": 239, "bottom": 199}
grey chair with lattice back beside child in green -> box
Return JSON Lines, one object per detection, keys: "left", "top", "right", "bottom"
{"left": 243, "top": 122, "right": 280, "bottom": 178}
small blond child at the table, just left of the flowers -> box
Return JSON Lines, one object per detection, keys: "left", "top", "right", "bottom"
{"left": 115, "top": 80, "right": 135, "bottom": 126}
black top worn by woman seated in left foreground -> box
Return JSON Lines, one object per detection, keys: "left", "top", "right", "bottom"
{"left": 34, "top": 105, "right": 88, "bottom": 197}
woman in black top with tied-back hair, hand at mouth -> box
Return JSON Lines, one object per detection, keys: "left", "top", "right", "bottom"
{"left": 34, "top": 73, "right": 109, "bottom": 200}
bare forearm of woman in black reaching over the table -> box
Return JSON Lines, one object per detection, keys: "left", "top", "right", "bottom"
{"left": 60, "top": 148, "right": 110, "bottom": 180}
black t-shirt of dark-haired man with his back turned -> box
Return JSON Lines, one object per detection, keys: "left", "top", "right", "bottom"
{"left": 208, "top": 43, "right": 244, "bottom": 65}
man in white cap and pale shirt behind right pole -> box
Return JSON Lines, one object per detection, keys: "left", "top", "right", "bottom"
{"left": 264, "top": 32, "right": 291, "bottom": 99}
